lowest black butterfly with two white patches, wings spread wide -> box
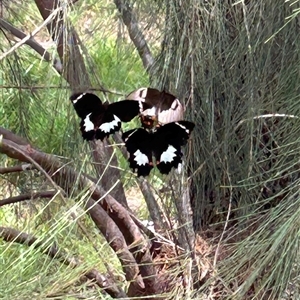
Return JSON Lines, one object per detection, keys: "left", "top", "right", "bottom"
{"left": 122, "top": 121, "right": 195, "bottom": 176}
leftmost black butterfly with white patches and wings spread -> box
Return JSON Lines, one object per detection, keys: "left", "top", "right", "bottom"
{"left": 70, "top": 93, "right": 149, "bottom": 141}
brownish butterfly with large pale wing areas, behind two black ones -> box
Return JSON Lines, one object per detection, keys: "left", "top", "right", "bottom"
{"left": 126, "top": 88, "right": 184, "bottom": 128}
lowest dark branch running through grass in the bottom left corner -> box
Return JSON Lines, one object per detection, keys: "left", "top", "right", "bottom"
{"left": 0, "top": 227, "right": 127, "bottom": 298}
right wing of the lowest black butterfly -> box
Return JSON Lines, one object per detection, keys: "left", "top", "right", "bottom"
{"left": 153, "top": 121, "right": 195, "bottom": 174}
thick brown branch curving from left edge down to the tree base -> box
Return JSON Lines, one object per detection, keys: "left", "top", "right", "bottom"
{"left": 0, "top": 126, "right": 157, "bottom": 294}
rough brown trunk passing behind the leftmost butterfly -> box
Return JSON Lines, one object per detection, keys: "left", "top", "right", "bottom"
{"left": 35, "top": 0, "right": 127, "bottom": 206}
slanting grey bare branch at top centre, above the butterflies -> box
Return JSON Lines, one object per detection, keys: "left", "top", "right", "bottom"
{"left": 114, "top": 0, "right": 154, "bottom": 71}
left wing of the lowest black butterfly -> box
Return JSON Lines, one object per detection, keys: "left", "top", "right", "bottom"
{"left": 122, "top": 128, "right": 153, "bottom": 176}
